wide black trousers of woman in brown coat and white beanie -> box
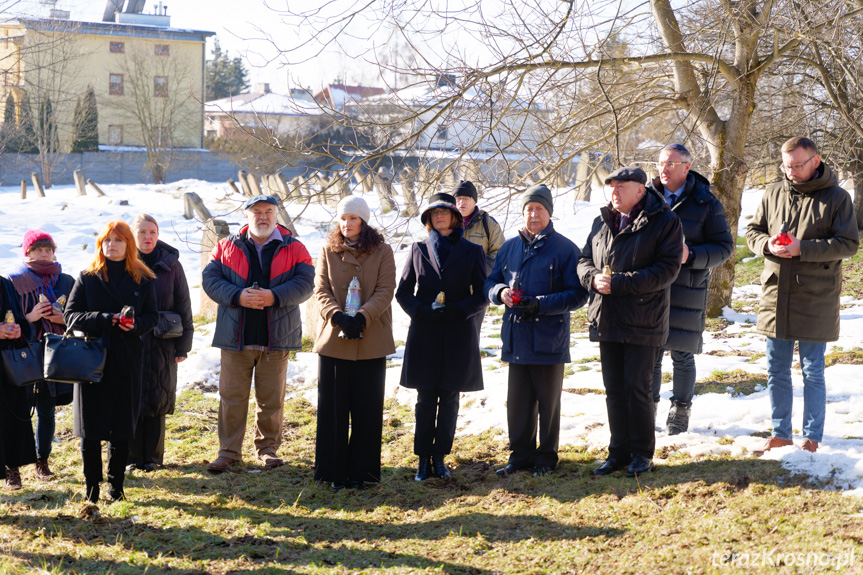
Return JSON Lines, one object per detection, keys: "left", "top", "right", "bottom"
{"left": 315, "top": 355, "right": 386, "bottom": 483}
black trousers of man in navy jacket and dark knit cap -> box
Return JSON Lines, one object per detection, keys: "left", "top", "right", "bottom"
{"left": 506, "top": 363, "right": 563, "bottom": 469}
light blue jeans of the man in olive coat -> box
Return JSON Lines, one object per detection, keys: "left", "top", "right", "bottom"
{"left": 767, "top": 337, "right": 827, "bottom": 443}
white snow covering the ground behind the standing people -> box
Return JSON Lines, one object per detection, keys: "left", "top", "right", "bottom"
{"left": 0, "top": 180, "right": 863, "bottom": 495}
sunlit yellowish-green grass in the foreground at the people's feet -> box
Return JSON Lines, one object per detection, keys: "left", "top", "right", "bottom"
{"left": 0, "top": 242, "right": 863, "bottom": 575}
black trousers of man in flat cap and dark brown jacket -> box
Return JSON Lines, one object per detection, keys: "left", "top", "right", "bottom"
{"left": 599, "top": 342, "right": 662, "bottom": 461}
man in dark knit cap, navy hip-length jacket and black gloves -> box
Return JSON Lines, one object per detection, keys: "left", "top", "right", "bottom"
{"left": 485, "top": 184, "right": 587, "bottom": 477}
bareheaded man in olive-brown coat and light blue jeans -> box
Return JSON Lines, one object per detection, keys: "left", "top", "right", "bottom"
{"left": 746, "top": 137, "right": 859, "bottom": 455}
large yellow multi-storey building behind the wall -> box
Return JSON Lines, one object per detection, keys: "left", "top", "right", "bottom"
{"left": 0, "top": 13, "right": 213, "bottom": 152}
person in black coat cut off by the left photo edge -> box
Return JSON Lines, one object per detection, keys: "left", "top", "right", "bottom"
{"left": 0, "top": 277, "right": 36, "bottom": 491}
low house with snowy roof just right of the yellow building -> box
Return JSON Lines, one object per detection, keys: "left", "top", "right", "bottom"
{"left": 204, "top": 84, "right": 323, "bottom": 138}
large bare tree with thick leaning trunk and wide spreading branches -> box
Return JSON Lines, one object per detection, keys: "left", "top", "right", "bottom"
{"left": 256, "top": 0, "right": 863, "bottom": 315}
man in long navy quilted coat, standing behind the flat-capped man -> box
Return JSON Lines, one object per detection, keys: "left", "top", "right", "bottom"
{"left": 649, "top": 144, "right": 734, "bottom": 435}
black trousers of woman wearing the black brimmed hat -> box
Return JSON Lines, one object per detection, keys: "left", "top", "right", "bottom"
{"left": 414, "top": 388, "right": 461, "bottom": 457}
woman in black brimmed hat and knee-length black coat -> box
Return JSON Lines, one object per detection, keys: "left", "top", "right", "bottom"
{"left": 396, "top": 194, "right": 487, "bottom": 481}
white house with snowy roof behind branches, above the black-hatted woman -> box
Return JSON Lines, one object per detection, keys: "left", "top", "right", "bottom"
{"left": 345, "top": 74, "right": 552, "bottom": 153}
